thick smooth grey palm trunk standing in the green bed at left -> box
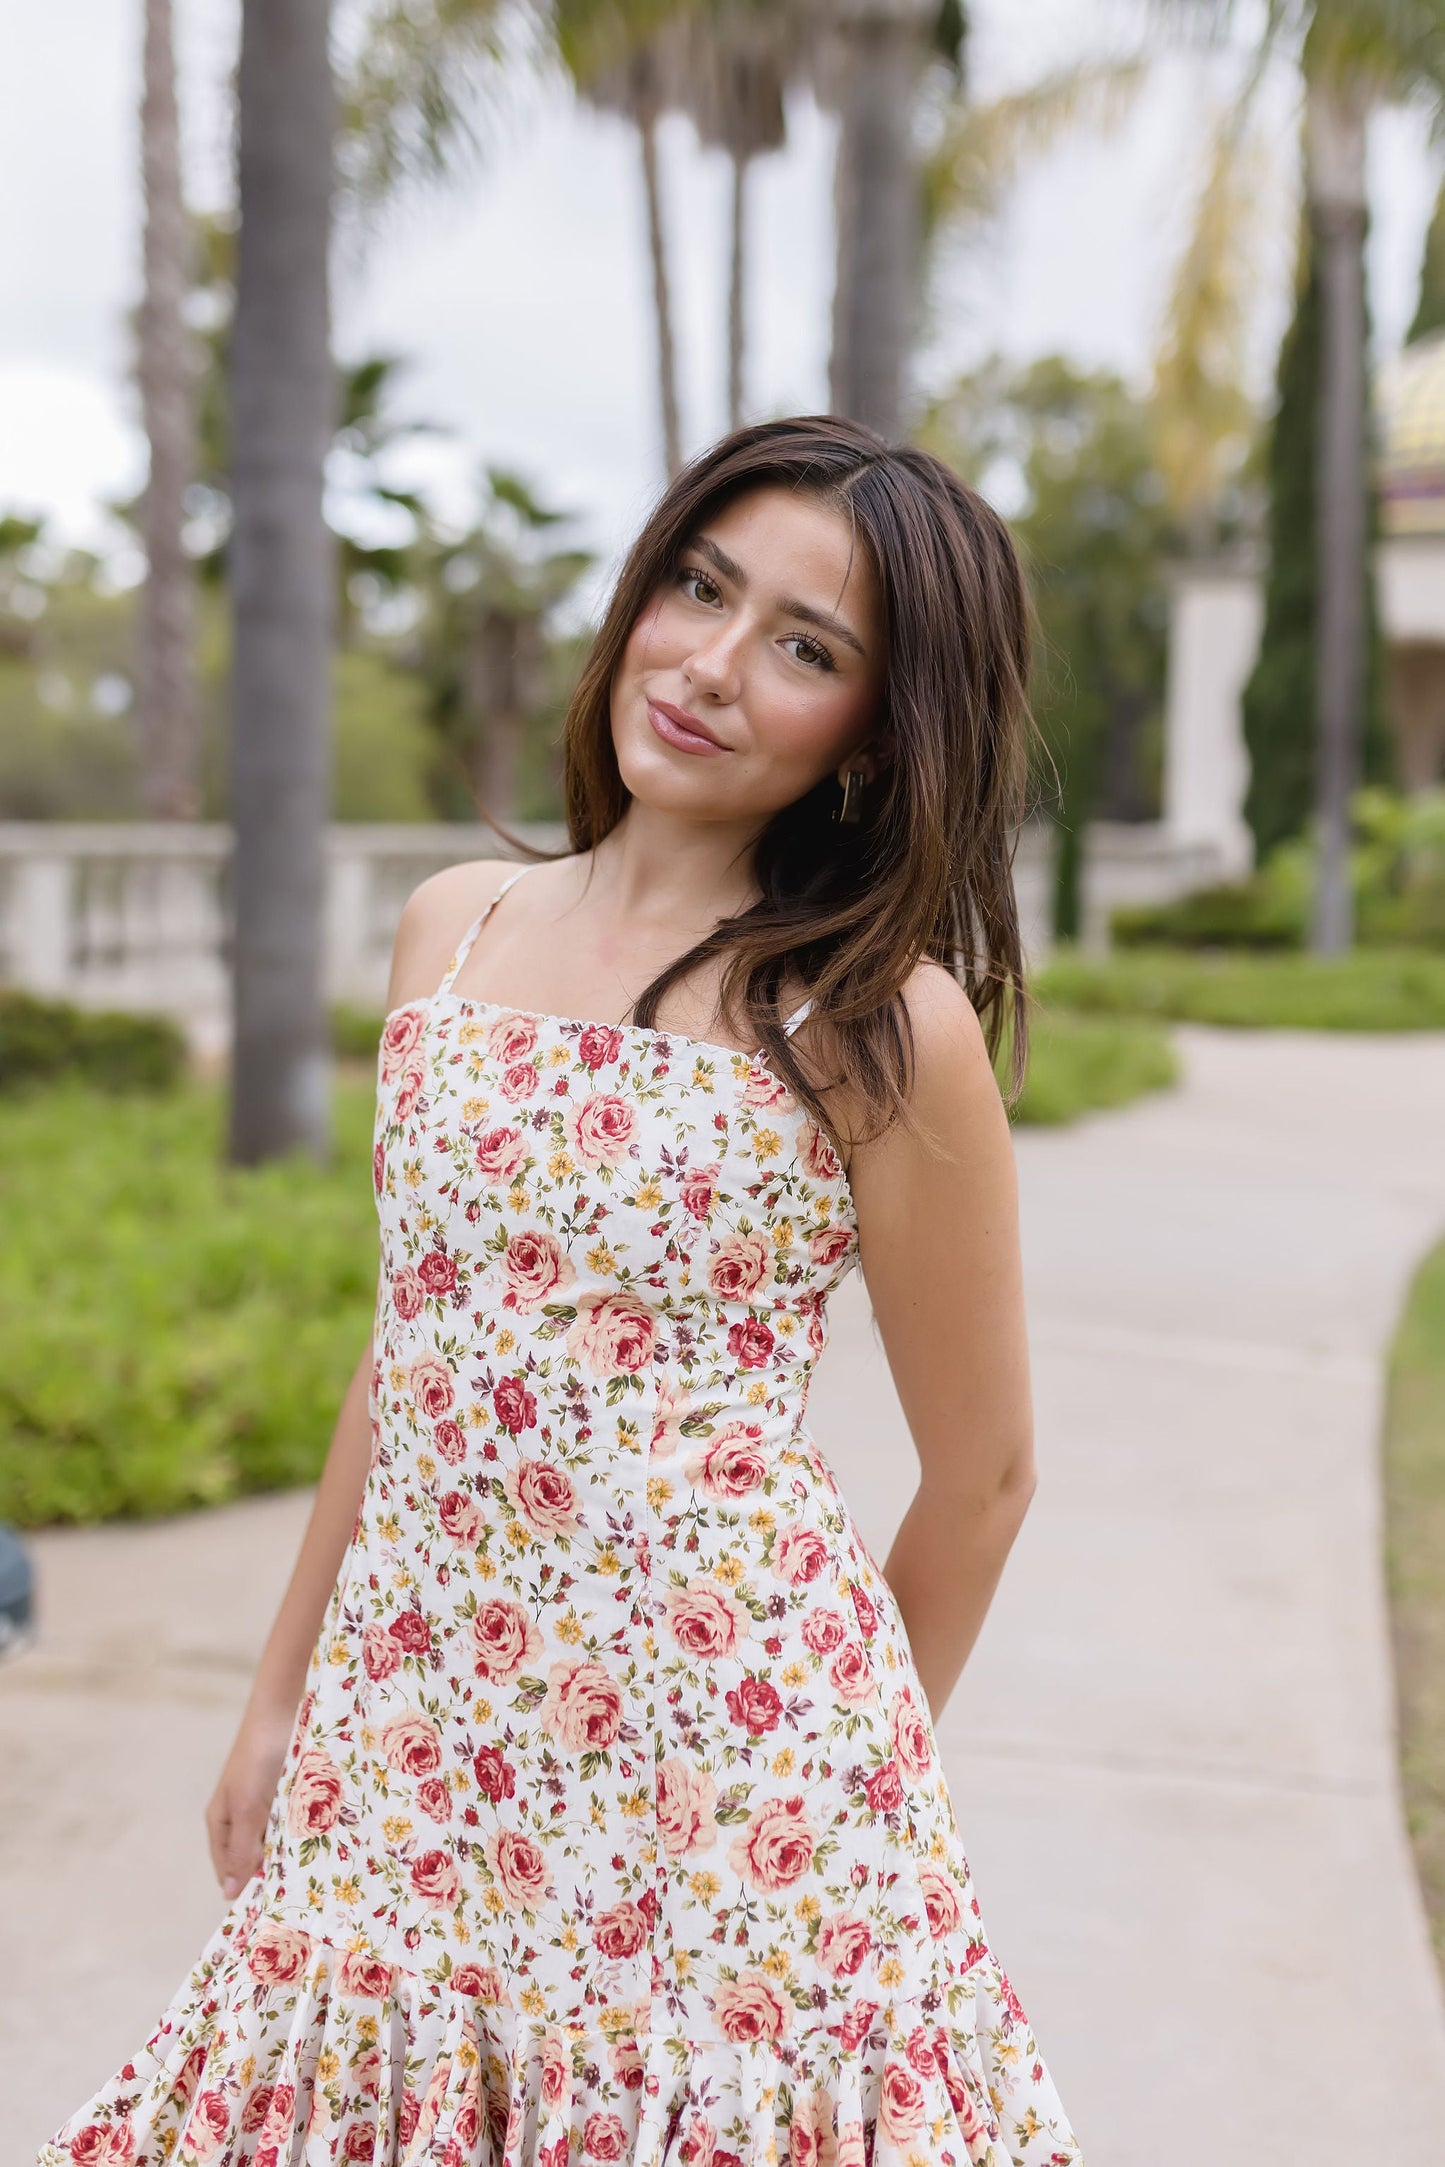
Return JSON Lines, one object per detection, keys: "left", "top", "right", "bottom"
{"left": 230, "top": 0, "right": 334, "bottom": 1162}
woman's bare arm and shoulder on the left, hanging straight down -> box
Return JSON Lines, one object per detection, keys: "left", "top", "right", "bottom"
{"left": 206, "top": 862, "right": 507, "bottom": 1900}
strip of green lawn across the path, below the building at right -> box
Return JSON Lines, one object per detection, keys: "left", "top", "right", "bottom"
{"left": 1033, "top": 947, "right": 1445, "bottom": 1031}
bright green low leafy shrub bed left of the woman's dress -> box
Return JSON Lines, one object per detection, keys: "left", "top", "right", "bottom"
{"left": 0, "top": 1081, "right": 377, "bottom": 1526}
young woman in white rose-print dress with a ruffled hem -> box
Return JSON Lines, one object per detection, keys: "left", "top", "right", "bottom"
{"left": 41, "top": 418, "right": 1079, "bottom": 2167}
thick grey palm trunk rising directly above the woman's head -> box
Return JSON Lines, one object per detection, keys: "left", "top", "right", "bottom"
{"left": 830, "top": 0, "right": 932, "bottom": 438}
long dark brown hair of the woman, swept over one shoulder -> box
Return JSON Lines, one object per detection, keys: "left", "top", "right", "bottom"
{"left": 513, "top": 414, "right": 1033, "bottom": 1133}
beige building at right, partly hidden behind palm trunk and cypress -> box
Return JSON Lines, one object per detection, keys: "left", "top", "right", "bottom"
{"left": 1163, "top": 332, "right": 1445, "bottom": 871}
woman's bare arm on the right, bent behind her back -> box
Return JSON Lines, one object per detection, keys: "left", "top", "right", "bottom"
{"left": 849, "top": 964, "right": 1036, "bottom": 1716}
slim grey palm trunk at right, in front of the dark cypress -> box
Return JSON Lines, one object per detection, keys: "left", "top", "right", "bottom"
{"left": 1306, "top": 78, "right": 1369, "bottom": 956}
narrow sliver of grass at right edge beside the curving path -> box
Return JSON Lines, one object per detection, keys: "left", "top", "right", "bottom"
{"left": 1384, "top": 1242, "right": 1445, "bottom": 1972}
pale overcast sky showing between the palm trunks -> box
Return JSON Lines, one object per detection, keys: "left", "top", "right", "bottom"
{"left": 0, "top": 0, "right": 1439, "bottom": 580}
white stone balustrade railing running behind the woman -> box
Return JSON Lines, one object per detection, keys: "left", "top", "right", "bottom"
{"left": 0, "top": 821, "right": 1224, "bottom": 1047}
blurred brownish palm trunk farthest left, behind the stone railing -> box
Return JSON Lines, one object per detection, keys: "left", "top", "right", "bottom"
{"left": 136, "top": 0, "right": 199, "bottom": 819}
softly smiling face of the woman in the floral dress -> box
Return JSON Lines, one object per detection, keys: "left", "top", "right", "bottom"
{"left": 611, "top": 488, "right": 886, "bottom": 823}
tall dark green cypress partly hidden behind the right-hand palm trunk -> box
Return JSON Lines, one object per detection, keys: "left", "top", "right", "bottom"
{"left": 1244, "top": 221, "right": 1393, "bottom": 860}
